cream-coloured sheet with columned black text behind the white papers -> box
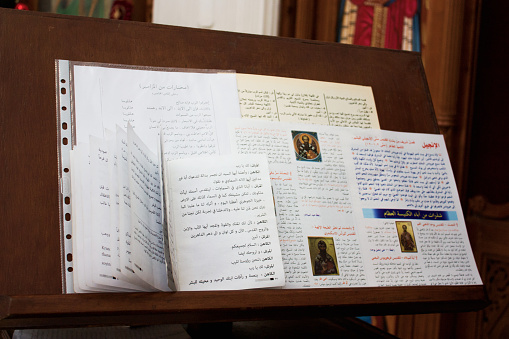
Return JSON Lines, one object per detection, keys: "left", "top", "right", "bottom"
{"left": 237, "top": 74, "right": 380, "bottom": 129}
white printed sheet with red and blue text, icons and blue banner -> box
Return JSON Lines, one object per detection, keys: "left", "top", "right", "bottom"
{"left": 231, "top": 119, "right": 481, "bottom": 288}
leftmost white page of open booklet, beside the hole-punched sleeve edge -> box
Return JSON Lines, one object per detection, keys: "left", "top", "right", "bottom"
{"left": 71, "top": 143, "right": 141, "bottom": 292}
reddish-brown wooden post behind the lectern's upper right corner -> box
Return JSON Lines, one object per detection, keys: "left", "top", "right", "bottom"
{"left": 421, "top": 0, "right": 480, "bottom": 202}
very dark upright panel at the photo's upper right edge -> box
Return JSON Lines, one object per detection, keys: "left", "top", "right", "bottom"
{"left": 468, "top": 1, "right": 509, "bottom": 203}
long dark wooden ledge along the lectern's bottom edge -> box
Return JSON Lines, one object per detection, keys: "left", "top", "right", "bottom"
{"left": 0, "top": 286, "right": 485, "bottom": 328}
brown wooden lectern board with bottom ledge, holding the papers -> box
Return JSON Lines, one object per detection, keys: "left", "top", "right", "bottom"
{"left": 0, "top": 9, "right": 486, "bottom": 328}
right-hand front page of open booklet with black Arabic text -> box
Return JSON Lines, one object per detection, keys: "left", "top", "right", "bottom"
{"left": 165, "top": 155, "right": 284, "bottom": 291}
